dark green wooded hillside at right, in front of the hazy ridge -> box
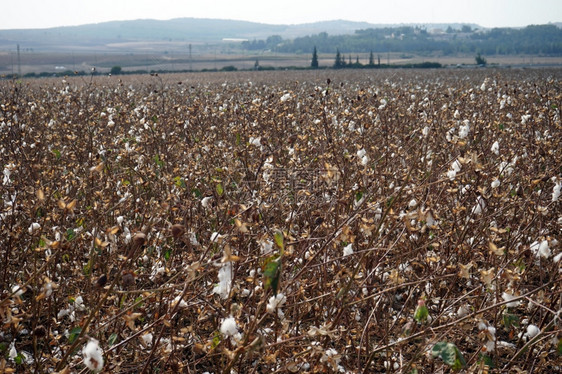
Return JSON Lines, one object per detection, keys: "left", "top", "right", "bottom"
{"left": 242, "top": 25, "right": 562, "bottom": 55}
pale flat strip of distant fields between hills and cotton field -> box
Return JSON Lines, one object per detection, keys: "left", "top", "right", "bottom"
{"left": 0, "top": 48, "right": 562, "bottom": 75}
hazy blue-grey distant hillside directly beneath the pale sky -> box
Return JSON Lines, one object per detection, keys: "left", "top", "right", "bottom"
{"left": 0, "top": 18, "right": 478, "bottom": 52}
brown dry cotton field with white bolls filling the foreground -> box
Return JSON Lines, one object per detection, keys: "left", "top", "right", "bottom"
{"left": 0, "top": 69, "right": 562, "bottom": 374}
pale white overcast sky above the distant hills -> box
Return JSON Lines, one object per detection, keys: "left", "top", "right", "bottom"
{"left": 0, "top": 0, "right": 562, "bottom": 29}
